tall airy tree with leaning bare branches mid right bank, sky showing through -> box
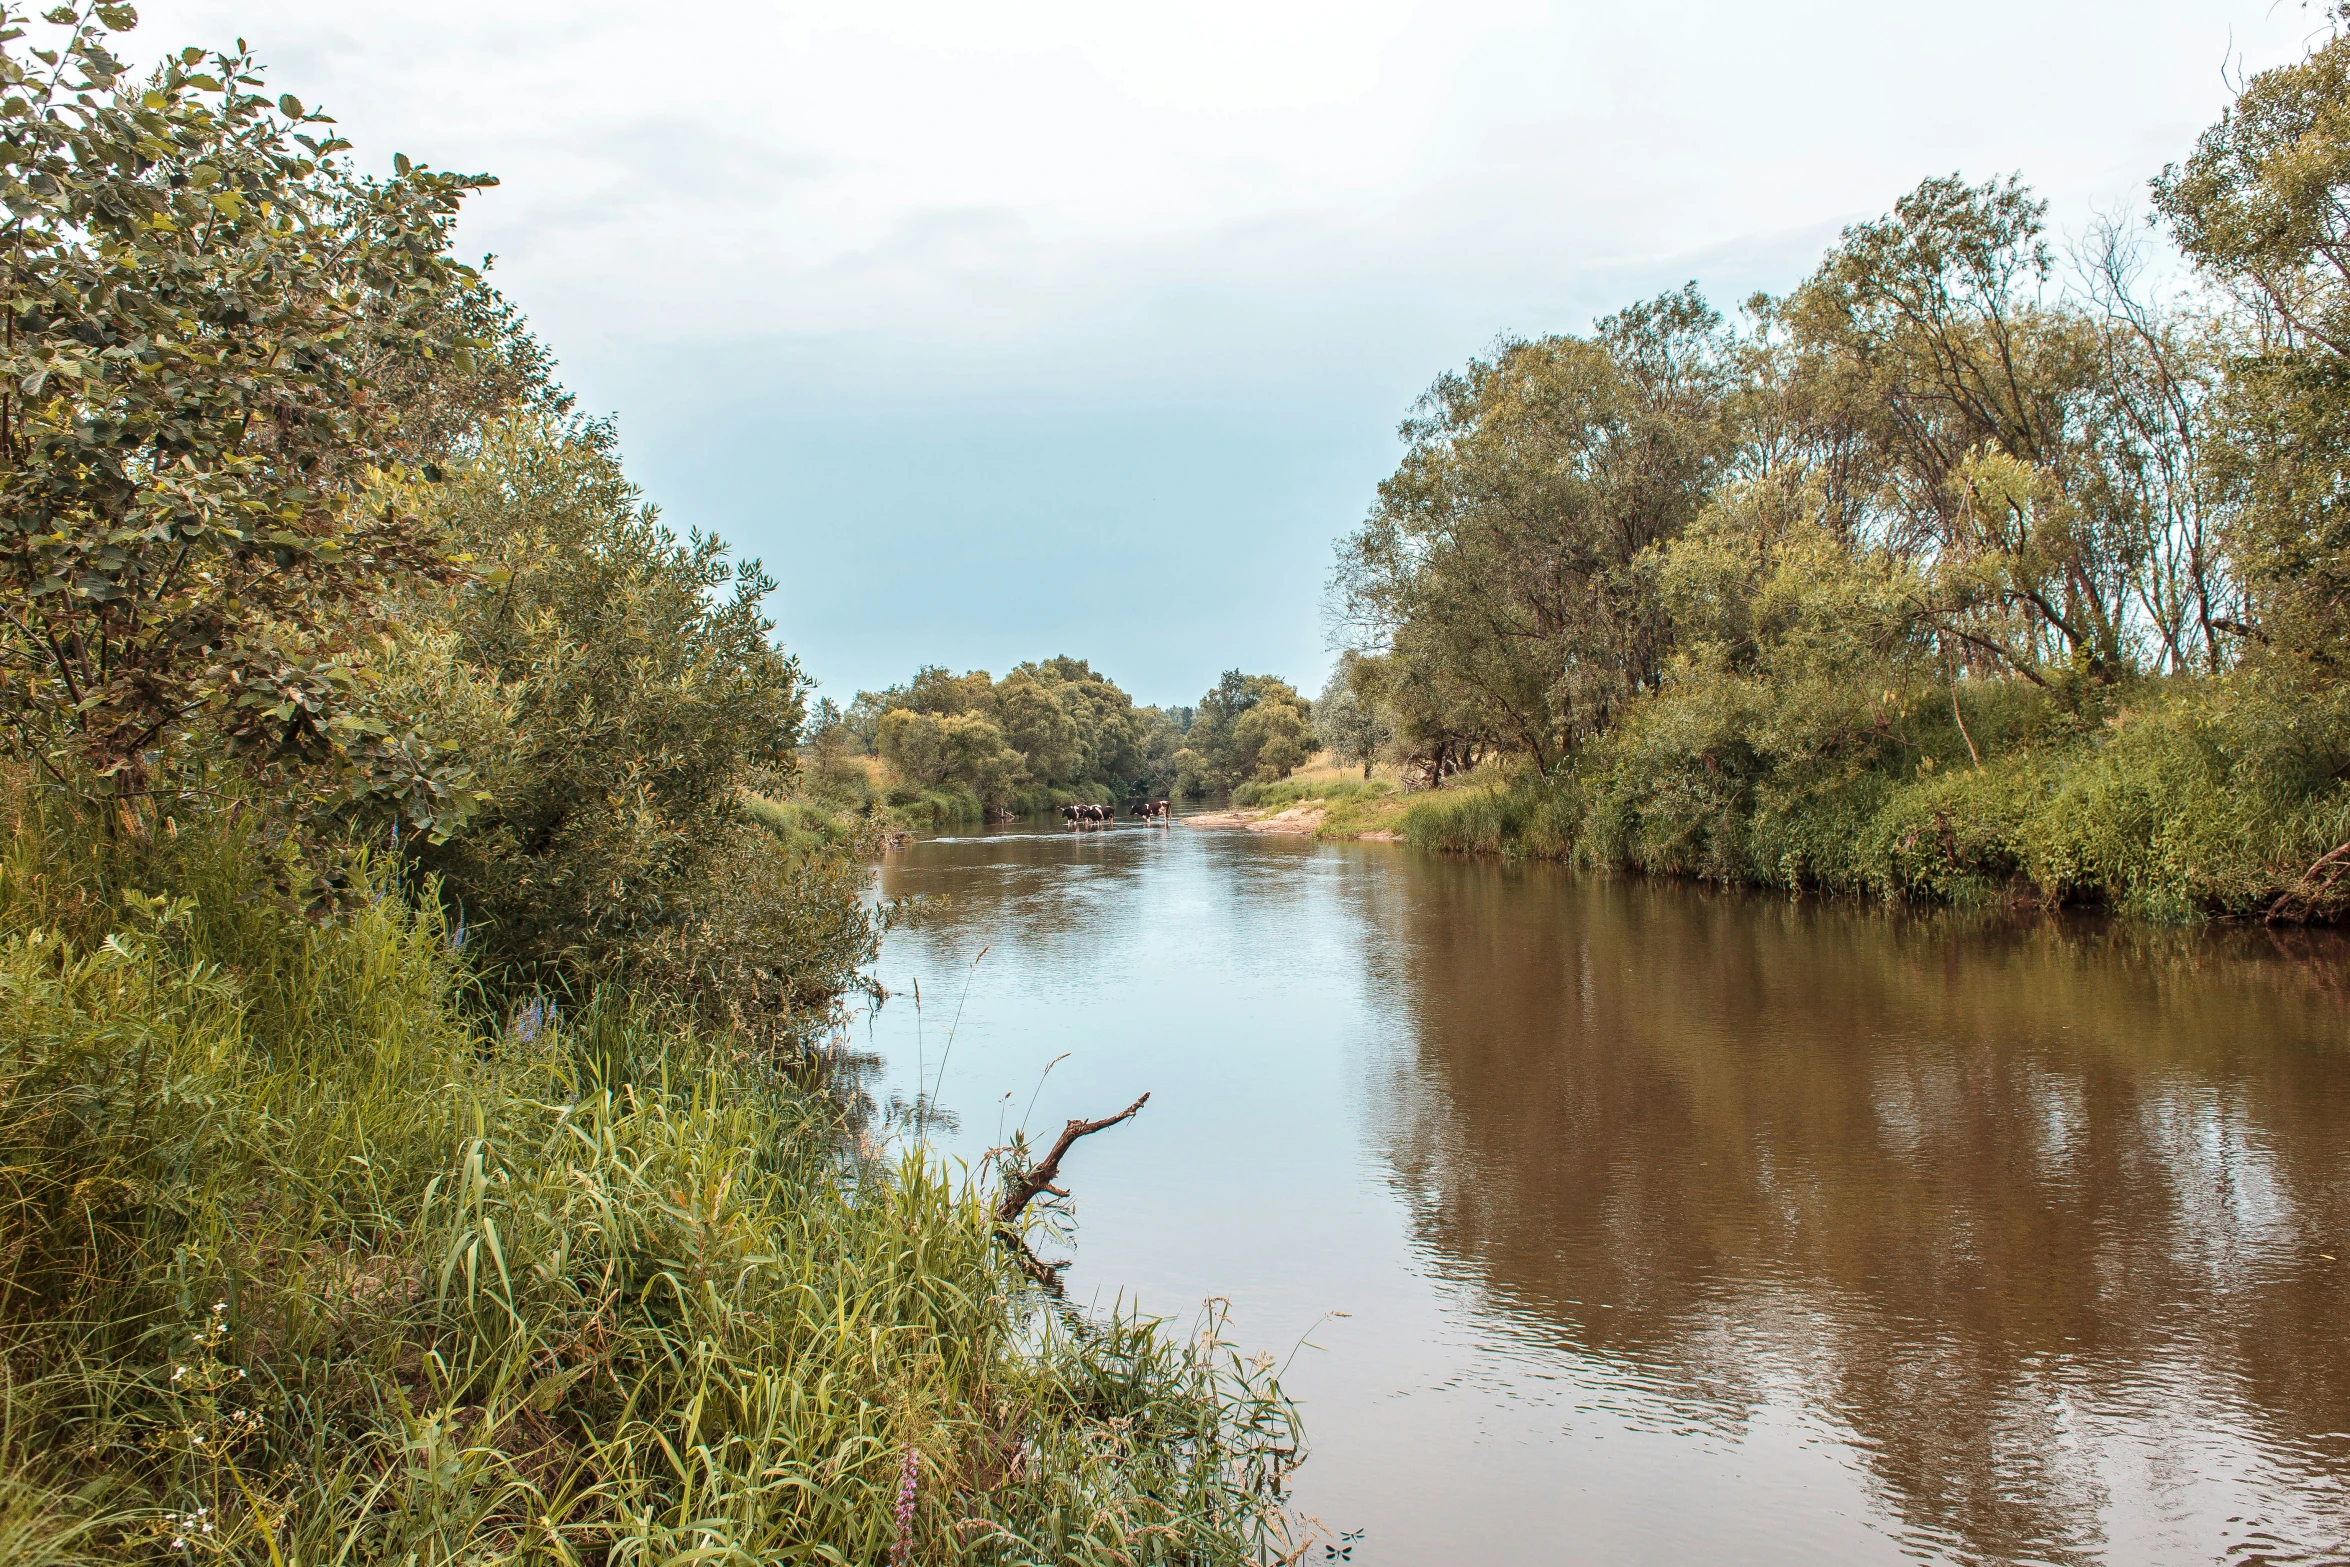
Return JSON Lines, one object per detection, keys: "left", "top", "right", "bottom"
{"left": 1765, "top": 176, "right": 2221, "bottom": 684}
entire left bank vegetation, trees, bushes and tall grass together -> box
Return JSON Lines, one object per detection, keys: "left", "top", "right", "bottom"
{"left": 0, "top": 5, "right": 1297, "bottom": 1567}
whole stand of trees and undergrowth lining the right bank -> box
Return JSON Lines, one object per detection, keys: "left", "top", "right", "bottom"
{"left": 1321, "top": 12, "right": 2350, "bottom": 919}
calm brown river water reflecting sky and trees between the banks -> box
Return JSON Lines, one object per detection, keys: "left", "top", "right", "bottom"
{"left": 862, "top": 825, "right": 2350, "bottom": 1567}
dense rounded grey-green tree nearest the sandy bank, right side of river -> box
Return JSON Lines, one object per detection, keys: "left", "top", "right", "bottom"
{"left": 1330, "top": 284, "right": 1730, "bottom": 768}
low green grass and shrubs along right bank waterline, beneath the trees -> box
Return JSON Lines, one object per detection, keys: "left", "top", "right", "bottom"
{"left": 1403, "top": 679, "right": 2350, "bottom": 921}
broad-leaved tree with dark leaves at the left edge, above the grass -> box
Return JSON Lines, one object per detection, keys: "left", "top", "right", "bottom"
{"left": 0, "top": 5, "right": 489, "bottom": 834}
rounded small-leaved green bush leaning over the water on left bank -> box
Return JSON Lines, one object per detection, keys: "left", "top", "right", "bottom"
{"left": 392, "top": 416, "right": 872, "bottom": 1048}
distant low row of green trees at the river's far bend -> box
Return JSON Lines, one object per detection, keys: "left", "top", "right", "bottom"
{"left": 806, "top": 658, "right": 1318, "bottom": 820}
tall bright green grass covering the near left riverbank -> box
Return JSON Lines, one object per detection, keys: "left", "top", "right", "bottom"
{"left": 0, "top": 785, "right": 1297, "bottom": 1567}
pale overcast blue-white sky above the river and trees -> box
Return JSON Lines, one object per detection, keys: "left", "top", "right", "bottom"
{"left": 122, "top": 0, "right": 2322, "bottom": 702}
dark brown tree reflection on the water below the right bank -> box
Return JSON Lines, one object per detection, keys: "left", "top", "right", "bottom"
{"left": 1356, "top": 862, "right": 2350, "bottom": 1562}
